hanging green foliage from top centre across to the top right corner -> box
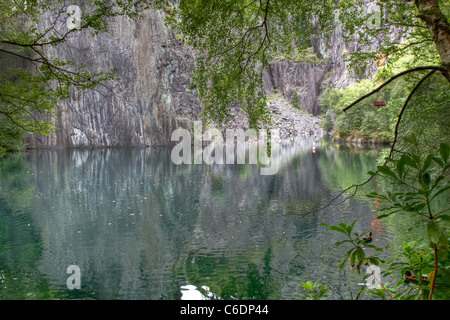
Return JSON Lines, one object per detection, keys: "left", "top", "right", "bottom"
{"left": 156, "top": 0, "right": 450, "bottom": 131}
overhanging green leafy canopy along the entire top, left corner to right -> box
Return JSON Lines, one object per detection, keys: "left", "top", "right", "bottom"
{"left": 0, "top": 0, "right": 450, "bottom": 151}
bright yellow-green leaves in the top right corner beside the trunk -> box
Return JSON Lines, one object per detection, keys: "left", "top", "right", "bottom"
{"left": 338, "top": 0, "right": 450, "bottom": 77}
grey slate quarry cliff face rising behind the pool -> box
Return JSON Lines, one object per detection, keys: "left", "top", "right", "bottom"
{"left": 27, "top": 7, "right": 352, "bottom": 148}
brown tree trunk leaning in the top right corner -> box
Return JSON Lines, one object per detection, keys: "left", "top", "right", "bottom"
{"left": 414, "top": 0, "right": 450, "bottom": 82}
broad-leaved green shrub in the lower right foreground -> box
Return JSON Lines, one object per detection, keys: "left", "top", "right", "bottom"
{"left": 322, "top": 140, "right": 450, "bottom": 300}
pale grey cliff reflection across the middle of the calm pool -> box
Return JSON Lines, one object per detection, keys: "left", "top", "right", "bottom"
{"left": 0, "top": 140, "right": 386, "bottom": 299}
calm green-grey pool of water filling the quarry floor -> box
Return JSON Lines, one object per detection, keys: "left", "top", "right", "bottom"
{"left": 0, "top": 138, "right": 389, "bottom": 300}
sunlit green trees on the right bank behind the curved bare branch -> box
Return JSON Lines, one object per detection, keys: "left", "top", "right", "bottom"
{"left": 320, "top": 55, "right": 450, "bottom": 144}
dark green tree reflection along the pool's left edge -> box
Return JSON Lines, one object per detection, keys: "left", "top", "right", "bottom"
{"left": 0, "top": 153, "right": 62, "bottom": 300}
